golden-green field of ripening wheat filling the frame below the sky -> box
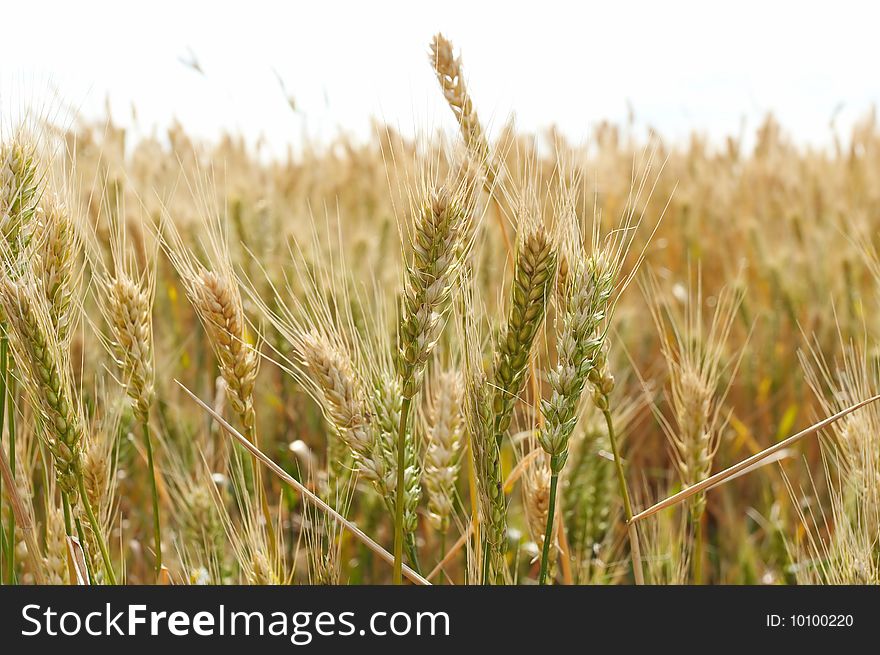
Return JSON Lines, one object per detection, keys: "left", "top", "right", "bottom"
{"left": 0, "top": 35, "right": 880, "bottom": 585}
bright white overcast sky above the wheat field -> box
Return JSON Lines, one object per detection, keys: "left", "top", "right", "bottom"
{"left": 0, "top": 0, "right": 880, "bottom": 152}
